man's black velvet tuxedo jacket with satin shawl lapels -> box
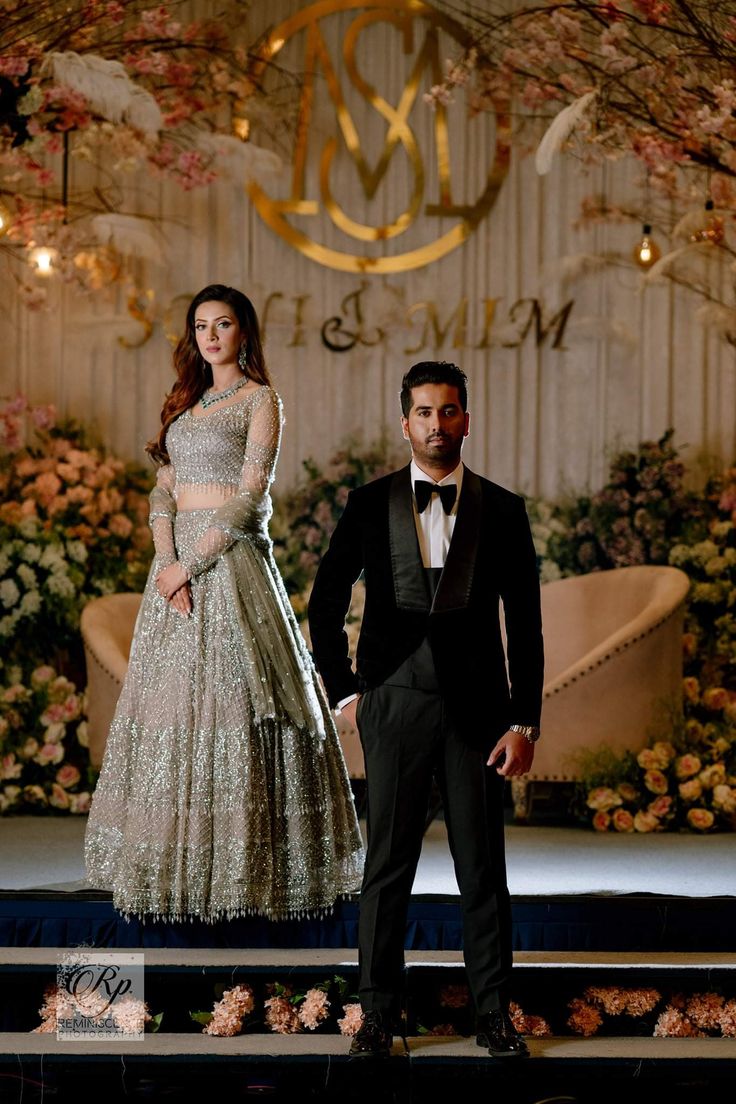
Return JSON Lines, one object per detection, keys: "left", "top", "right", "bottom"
{"left": 309, "top": 465, "right": 544, "bottom": 747}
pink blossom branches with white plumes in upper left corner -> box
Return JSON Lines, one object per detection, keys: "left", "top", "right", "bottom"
{"left": 0, "top": 0, "right": 284, "bottom": 308}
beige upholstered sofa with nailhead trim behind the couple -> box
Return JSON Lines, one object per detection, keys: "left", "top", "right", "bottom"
{"left": 82, "top": 566, "right": 689, "bottom": 790}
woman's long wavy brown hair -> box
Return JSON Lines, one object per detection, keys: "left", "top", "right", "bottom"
{"left": 146, "top": 284, "right": 270, "bottom": 464}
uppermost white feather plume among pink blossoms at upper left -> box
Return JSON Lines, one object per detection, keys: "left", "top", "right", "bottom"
{"left": 44, "top": 51, "right": 163, "bottom": 134}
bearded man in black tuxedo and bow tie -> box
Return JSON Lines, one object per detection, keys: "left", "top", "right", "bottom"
{"left": 309, "top": 361, "right": 543, "bottom": 1058}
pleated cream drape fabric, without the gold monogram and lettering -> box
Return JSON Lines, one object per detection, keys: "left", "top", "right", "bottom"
{"left": 0, "top": 0, "right": 736, "bottom": 496}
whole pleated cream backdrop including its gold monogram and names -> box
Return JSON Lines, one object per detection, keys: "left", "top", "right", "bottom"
{"left": 0, "top": 0, "right": 736, "bottom": 497}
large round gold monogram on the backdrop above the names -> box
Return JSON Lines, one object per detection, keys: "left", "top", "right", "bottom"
{"left": 248, "top": 0, "right": 510, "bottom": 273}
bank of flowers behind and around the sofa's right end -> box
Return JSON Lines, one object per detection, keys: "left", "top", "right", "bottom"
{"left": 530, "top": 429, "right": 736, "bottom": 832}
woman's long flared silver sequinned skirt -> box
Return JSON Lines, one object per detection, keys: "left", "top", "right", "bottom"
{"left": 85, "top": 510, "right": 363, "bottom": 921}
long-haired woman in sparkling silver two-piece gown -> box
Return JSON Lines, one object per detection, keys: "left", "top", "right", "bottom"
{"left": 85, "top": 285, "right": 363, "bottom": 921}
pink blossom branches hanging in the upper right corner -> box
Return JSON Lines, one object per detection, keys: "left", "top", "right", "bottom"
{"left": 425, "top": 0, "right": 736, "bottom": 342}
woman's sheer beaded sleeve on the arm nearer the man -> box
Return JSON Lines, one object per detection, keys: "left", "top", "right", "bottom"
{"left": 181, "top": 388, "right": 282, "bottom": 577}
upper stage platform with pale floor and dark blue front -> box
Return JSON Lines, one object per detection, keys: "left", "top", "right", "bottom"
{"left": 0, "top": 817, "right": 736, "bottom": 958}
